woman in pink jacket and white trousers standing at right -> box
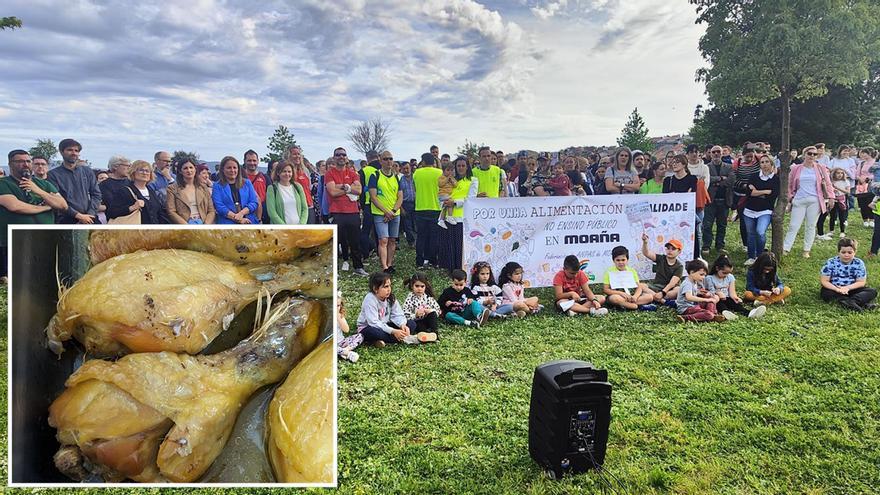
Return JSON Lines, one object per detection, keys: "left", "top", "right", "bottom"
{"left": 782, "top": 146, "right": 834, "bottom": 258}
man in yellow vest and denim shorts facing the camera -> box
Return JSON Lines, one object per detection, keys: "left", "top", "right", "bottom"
{"left": 367, "top": 151, "right": 403, "bottom": 273}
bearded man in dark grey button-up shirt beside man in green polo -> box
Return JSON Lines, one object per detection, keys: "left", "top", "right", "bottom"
{"left": 49, "top": 138, "right": 101, "bottom": 224}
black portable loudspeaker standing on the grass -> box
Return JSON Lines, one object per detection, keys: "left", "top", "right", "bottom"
{"left": 529, "top": 360, "right": 611, "bottom": 478}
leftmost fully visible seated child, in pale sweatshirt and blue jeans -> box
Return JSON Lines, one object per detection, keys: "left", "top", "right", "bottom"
{"left": 357, "top": 272, "right": 437, "bottom": 347}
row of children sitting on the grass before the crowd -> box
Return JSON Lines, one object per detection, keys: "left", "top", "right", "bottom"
{"left": 337, "top": 235, "right": 877, "bottom": 362}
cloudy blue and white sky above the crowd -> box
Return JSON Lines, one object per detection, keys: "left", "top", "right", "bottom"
{"left": 0, "top": 0, "right": 705, "bottom": 167}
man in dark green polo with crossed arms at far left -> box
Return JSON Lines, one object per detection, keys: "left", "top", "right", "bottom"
{"left": 0, "top": 150, "right": 67, "bottom": 283}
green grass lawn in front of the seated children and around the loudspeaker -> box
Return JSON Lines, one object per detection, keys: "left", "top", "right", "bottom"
{"left": 339, "top": 221, "right": 880, "bottom": 493}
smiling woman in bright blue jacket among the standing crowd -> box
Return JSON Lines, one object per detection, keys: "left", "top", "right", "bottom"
{"left": 211, "top": 156, "right": 260, "bottom": 225}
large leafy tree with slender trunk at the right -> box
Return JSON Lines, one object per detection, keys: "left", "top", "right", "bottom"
{"left": 689, "top": 0, "right": 880, "bottom": 256}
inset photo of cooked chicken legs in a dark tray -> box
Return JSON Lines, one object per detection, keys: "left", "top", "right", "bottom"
{"left": 9, "top": 226, "right": 336, "bottom": 486}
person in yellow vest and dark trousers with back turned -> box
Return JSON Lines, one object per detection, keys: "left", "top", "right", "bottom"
{"left": 412, "top": 154, "right": 440, "bottom": 268}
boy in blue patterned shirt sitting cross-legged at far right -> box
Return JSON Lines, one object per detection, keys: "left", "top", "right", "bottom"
{"left": 819, "top": 237, "right": 877, "bottom": 311}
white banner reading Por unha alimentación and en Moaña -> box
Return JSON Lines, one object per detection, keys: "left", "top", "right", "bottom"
{"left": 463, "top": 193, "right": 696, "bottom": 287}
